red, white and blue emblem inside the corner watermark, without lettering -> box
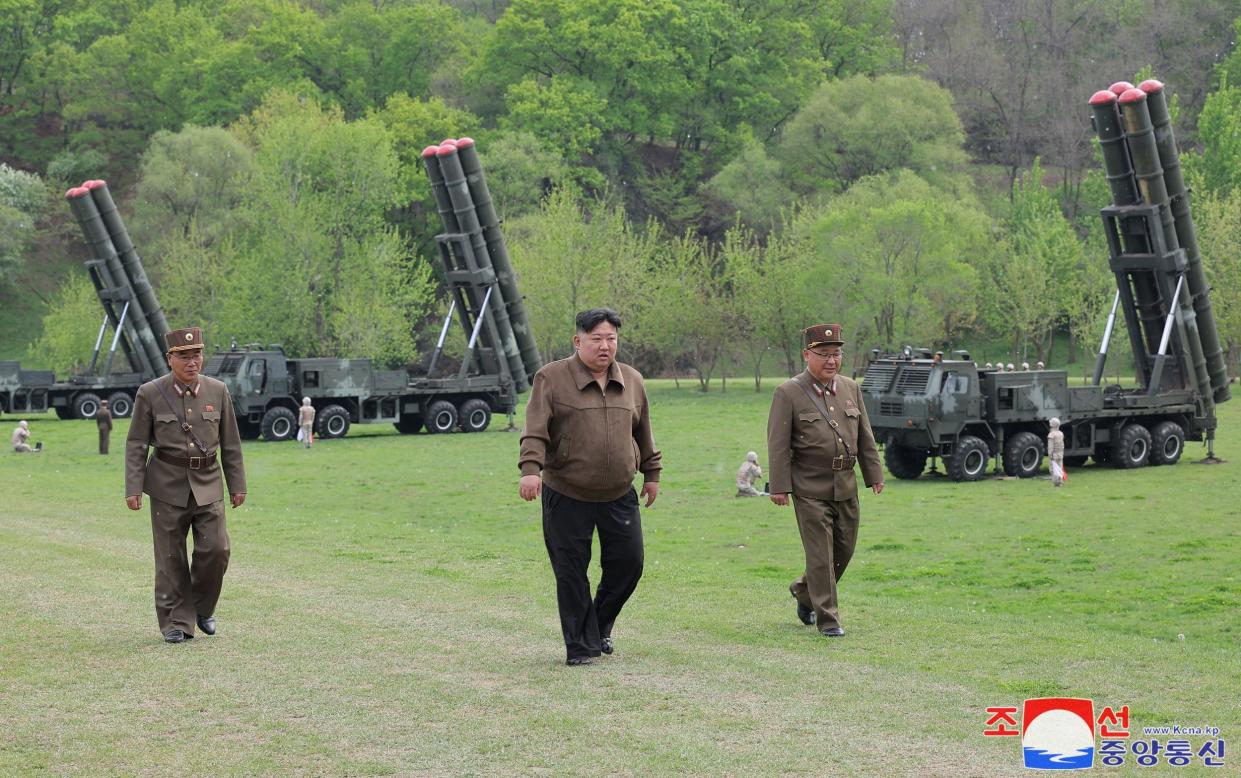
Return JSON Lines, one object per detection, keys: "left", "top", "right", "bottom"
{"left": 1021, "top": 697, "right": 1095, "bottom": 769}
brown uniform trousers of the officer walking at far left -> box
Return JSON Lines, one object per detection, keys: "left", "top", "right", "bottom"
{"left": 151, "top": 493, "right": 230, "bottom": 637}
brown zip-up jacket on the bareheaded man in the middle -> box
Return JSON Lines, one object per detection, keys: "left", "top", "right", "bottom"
{"left": 517, "top": 354, "right": 663, "bottom": 503}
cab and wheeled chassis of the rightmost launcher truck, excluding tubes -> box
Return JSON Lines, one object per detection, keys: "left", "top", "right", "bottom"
{"left": 861, "top": 349, "right": 1215, "bottom": 481}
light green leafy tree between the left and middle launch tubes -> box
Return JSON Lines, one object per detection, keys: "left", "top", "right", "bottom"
{"left": 140, "top": 93, "right": 432, "bottom": 364}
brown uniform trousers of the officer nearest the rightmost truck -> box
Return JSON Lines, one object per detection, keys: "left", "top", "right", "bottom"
{"left": 789, "top": 494, "right": 859, "bottom": 630}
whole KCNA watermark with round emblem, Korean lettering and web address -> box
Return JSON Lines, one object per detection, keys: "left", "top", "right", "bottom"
{"left": 983, "top": 697, "right": 1224, "bottom": 769}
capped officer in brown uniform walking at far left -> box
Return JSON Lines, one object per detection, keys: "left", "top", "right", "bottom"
{"left": 125, "top": 326, "right": 246, "bottom": 643}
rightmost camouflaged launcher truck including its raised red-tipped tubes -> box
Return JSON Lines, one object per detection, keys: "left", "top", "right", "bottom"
{"left": 861, "top": 81, "right": 1231, "bottom": 480}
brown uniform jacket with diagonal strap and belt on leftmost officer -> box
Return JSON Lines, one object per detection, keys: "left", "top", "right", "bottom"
{"left": 125, "top": 373, "right": 246, "bottom": 506}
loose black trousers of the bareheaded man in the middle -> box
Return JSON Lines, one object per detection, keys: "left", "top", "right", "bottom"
{"left": 542, "top": 484, "right": 643, "bottom": 659}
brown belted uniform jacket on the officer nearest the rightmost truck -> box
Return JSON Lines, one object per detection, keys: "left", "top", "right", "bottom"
{"left": 767, "top": 371, "right": 884, "bottom": 500}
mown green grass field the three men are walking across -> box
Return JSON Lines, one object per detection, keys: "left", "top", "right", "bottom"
{"left": 0, "top": 382, "right": 1241, "bottom": 776}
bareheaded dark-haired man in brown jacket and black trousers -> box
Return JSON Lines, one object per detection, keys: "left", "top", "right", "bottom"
{"left": 517, "top": 308, "right": 663, "bottom": 665}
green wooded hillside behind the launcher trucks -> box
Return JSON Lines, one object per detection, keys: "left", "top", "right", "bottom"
{"left": 0, "top": 0, "right": 1241, "bottom": 390}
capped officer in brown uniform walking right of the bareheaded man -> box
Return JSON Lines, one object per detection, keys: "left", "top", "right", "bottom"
{"left": 767, "top": 324, "right": 884, "bottom": 638}
